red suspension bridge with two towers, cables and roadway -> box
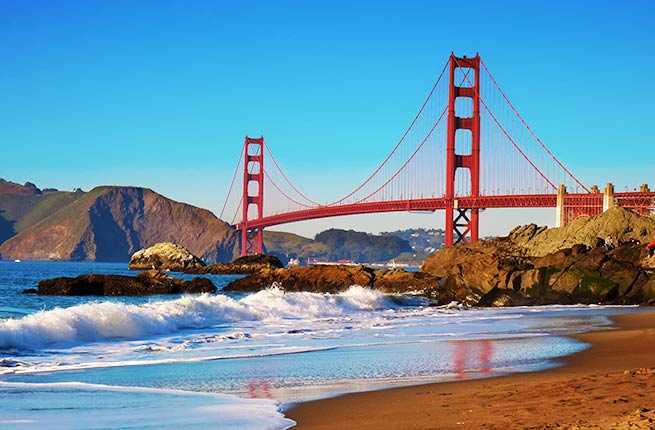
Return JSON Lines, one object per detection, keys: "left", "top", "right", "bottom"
{"left": 220, "top": 54, "right": 655, "bottom": 255}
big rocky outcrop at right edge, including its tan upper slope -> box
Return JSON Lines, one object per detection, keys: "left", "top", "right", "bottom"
{"left": 422, "top": 208, "right": 655, "bottom": 306}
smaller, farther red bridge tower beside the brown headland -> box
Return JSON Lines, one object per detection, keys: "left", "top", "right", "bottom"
{"left": 241, "top": 136, "right": 264, "bottom": 256}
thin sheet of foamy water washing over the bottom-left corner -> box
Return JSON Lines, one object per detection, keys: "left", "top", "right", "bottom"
{"left": 0, "top": 381, "right": 295, "bottom": 430}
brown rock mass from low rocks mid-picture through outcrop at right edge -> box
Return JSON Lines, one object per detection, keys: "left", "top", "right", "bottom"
{"left": 225, "top": 209, "right": 655, "bottom": 306}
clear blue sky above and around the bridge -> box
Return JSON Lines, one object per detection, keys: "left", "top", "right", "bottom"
{"left": 0, "top": 0, "right": 655, "bottom": 234}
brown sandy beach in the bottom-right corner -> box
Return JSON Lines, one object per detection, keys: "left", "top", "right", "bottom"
{"left": 286, "top": 311, "right": 655, "bottom": 430}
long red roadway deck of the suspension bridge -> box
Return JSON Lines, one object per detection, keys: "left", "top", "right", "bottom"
{"left": 236, "top": 192, "right": 655, "bottom": 230}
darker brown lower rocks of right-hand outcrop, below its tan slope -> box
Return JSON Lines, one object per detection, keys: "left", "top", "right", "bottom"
{"left": 422, "top": 220, "right": 655, "bottom": 306}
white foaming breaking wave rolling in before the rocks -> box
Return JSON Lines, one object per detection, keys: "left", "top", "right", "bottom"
{"left": 0, "top": 286, "right": 408, "bottom": 350}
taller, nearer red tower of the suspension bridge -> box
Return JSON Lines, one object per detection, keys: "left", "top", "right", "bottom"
{"left": 445, "top": 54, "right": 480, "bottom": 246}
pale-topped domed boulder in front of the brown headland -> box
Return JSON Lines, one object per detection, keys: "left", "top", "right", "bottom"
{"left": 128, "top": 242, "right": 205, "bottom": 272}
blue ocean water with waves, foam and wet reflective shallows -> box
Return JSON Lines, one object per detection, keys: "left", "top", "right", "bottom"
{"left": 0, "top": 262, "right": 635, "bottom": 429}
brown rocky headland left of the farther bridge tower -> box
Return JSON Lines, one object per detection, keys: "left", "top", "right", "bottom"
{"left": 0, "top": 181, "right": 238, "bottom": 262}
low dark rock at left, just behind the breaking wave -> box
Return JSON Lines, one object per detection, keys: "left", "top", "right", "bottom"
{"left": 32, "top": 270, "right": 216, "bottom": 296}
